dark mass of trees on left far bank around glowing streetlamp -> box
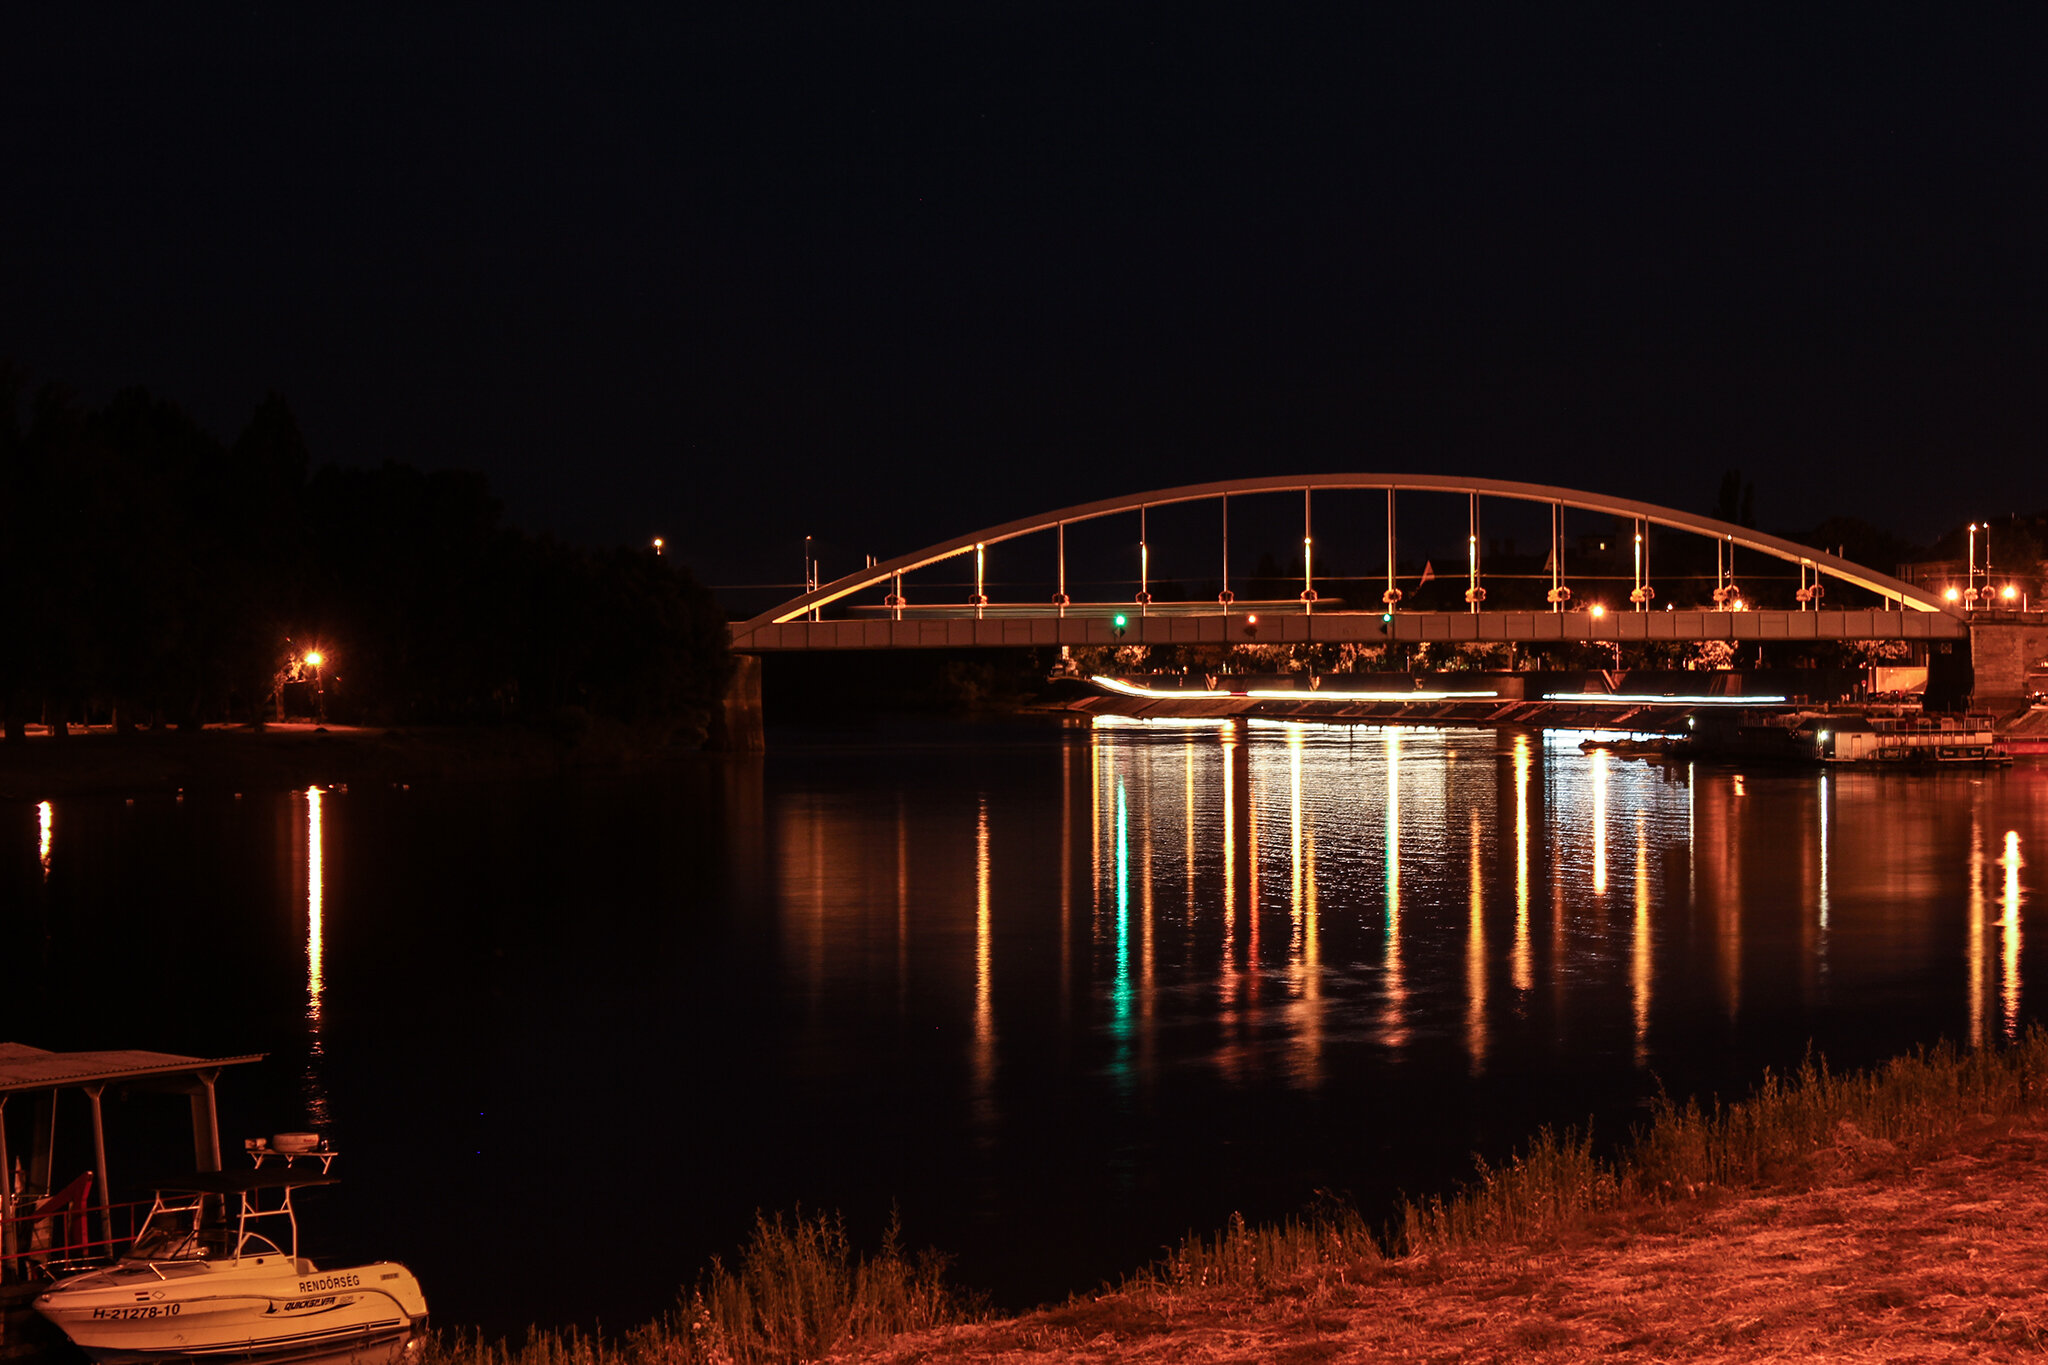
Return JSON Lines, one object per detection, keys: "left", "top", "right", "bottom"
{"left": 0, "top": 376, "right": 731, "bottom": 747}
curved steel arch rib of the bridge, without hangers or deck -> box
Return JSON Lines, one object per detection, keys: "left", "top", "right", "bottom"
{"left": 733, "top": 475, "right": 1954, "bottom": 649}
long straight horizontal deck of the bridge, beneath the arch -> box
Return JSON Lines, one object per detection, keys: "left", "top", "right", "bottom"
{"left": 733, "top": 604, "right": 1970, "bottom": 653}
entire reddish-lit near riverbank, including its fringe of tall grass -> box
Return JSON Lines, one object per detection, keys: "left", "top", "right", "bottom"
{"left": 424, "top": 1027, "right": 2048, "bottom": 1365}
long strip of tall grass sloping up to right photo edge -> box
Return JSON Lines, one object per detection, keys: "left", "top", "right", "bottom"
{"left": 1124, "top": 1027, "right": 2048, "bottom": 1295}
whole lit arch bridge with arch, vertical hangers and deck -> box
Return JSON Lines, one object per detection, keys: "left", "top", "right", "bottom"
{"left": 733, "top": 473, "right": 1970, "bottom": 655}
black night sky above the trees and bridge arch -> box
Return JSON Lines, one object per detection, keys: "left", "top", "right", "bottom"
{"left": 0, "top": 0, "right": 2048, "bottom": 581}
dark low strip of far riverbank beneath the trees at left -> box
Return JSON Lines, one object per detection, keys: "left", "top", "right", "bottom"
{"left": 0, "top": 718, "right": 702, "bottom": 800}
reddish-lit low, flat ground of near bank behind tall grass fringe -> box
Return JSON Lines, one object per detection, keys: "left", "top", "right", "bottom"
{"left": 860, "top": 1119, "right": 2048, "bottom": 1365}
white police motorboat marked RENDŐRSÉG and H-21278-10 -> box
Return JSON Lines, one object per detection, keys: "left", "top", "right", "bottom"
{"left": 35, "top": 1152, "right": 426, "bottom": 1365}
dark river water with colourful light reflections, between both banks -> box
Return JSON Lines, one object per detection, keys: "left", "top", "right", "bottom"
{"left": 0, "top": 720, "right": 2048, "bottom": 1332}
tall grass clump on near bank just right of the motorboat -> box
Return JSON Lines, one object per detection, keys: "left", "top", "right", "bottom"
{"left": 422, "top": 1209, "right": 973, "bottom": 1365}
